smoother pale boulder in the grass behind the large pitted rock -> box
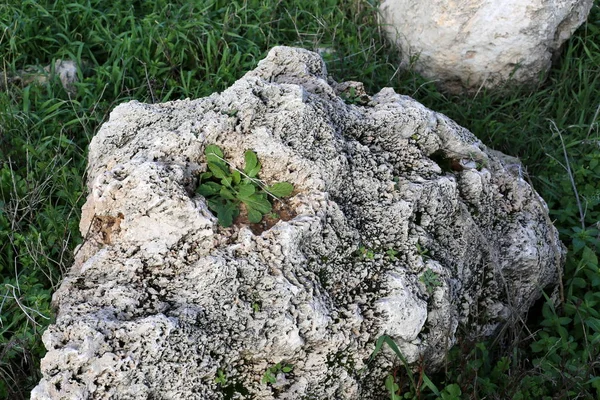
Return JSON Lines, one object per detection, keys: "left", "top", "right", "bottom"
{"left": 380, "top": 0, "right": 593, "bottom": 93}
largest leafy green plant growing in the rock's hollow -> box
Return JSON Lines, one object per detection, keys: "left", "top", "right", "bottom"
{"left": 196, "top": 145, "right": 294, "bottom": 228}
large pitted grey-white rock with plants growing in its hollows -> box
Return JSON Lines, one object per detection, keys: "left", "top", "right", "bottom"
{"left": 32, "top": 47, "right": 563, "bottom": 399}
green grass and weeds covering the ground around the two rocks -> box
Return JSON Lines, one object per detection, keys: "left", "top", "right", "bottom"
{"left": 0, "top": 0, "right": 600, "bottom": 399}
